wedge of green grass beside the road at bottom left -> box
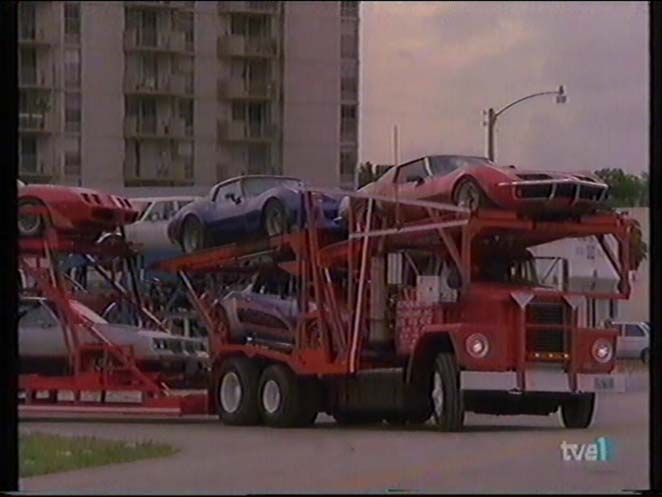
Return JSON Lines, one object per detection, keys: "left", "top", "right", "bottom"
{"left": 18, "top": 432, "right": 177, "bottom": 478}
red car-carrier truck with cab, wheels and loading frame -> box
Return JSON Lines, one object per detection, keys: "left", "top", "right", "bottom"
{"left": 153, "top": 191, "right": 636, "bottom": 431}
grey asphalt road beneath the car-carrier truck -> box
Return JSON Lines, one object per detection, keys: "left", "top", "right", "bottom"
{"left": 20, "top": 372, "right": 648, "bottom": 493}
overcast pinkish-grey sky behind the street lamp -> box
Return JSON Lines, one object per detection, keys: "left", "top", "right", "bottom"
{"left": 359, "top": 2, "right": 649, "bottom": 174}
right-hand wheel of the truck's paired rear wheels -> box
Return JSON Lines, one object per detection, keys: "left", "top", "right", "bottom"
{"left": 258, "top": 364, "right": 308, "bottom": 428}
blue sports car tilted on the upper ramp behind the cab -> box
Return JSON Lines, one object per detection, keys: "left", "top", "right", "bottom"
{"left": 168, "top": 175, "right": 339, "bottom": 253}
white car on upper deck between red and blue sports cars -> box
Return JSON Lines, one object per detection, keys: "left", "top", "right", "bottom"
{"left": 107, "top": 196, "right": 197, "bottom": 253}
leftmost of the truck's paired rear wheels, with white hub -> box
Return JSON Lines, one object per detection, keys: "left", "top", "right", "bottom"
{"left": 216, "top": 357, "right": 260, "bottom": 426}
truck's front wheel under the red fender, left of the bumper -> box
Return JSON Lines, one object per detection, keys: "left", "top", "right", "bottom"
{"left": 431, "top": 352, "right": 464, "bottom": 431}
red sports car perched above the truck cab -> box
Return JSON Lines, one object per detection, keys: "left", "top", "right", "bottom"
{"left": 352, "top": 155, "right": 608, "bottom": 214}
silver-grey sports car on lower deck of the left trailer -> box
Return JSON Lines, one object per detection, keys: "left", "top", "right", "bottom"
{"left": 18, "top": 297, "right": 208, "bottom": 385}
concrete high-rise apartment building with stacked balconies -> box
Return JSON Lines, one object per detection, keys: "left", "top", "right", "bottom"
{"left": 19, "top": 1, "right": 359, "bottom": 195}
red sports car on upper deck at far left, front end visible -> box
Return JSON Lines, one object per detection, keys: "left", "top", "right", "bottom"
{"left": 18, "top": 184, "right": 138, "bottom": 240}
